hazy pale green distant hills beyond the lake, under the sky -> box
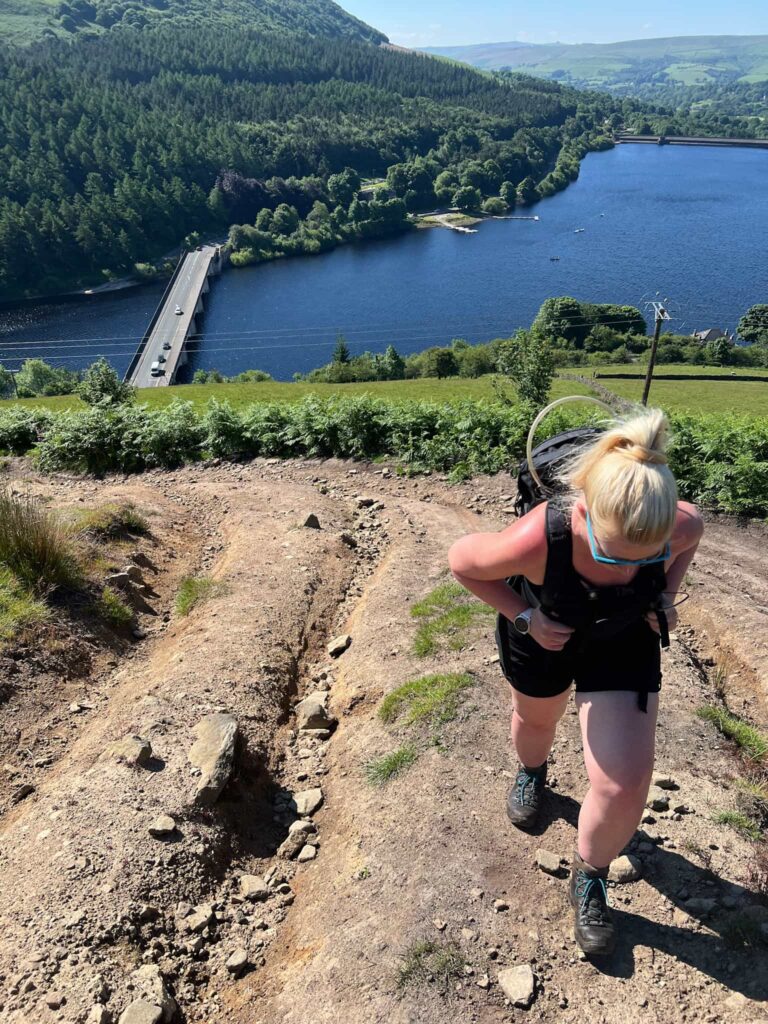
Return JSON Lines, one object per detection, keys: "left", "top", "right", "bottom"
{"left": 425, "top": 36, "right": 768, "bottom": 95}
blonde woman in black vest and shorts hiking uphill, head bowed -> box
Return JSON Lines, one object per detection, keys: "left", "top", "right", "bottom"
{"left": 450, "top": 410, "right": 703, "bottom": 954}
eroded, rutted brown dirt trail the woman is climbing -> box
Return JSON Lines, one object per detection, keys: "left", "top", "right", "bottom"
{"left": 0, "top": 461, "right": 768, "bottom": 1024}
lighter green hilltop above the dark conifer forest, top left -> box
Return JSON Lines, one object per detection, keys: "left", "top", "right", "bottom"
{"left": 0, "top": 0, "right": 388, "bottom": 44}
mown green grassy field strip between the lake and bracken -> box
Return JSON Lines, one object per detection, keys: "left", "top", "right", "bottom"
{"left": 0, "top": 366, "right": 768, "bottom": 416}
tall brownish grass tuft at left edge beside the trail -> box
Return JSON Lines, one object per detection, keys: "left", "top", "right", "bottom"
{"left": 0, "top": 488, "right": 82, "bottom": 595}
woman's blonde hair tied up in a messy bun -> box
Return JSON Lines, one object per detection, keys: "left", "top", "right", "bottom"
{"left": 563, "top": 409, "right": 678, "bottom": 545}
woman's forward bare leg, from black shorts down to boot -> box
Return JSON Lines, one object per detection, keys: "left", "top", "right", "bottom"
{"left": 577, "top": 690, "right": 658, "bottom": 867}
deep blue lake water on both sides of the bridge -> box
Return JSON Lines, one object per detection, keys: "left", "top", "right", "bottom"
{"left": 0, "top": 145, "right": 768, "bottom": 380}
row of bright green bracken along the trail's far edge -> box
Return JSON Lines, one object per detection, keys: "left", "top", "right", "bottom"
{"left": 0, "top": 395, "right": 768, "bottom": 517}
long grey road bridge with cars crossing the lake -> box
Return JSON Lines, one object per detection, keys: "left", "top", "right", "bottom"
{"left": 125, "top": 246, "right": 221, "bottom": 387}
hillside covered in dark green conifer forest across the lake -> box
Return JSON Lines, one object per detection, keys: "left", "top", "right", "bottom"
{"left": 0, "top": 25, "right": 636, "bottom": 297}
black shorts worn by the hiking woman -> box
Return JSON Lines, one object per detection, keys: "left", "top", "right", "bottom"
{"left": 496, "top": 615, "right": 662, "bottom": 702}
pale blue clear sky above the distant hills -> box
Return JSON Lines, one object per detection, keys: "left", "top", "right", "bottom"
{"left": 339, "top": 0, "right": 768, "bottom": 46}
